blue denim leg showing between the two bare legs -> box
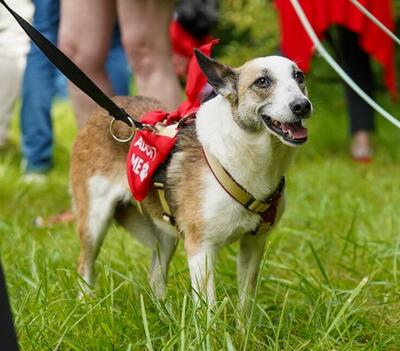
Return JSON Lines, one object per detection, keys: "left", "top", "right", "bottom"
{"left": 106, "top": 26, "right": 130, "bottom": 96}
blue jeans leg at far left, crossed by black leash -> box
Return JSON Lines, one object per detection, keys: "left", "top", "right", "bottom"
{"left": 21, "top": 0, "right": 59, "bottom": 173}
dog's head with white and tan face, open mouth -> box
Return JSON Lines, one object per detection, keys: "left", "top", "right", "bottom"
{"left": 195, "top": 50, "right": 312, "bottom": 146}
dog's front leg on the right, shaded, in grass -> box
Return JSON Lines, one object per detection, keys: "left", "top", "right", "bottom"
{"left": 237, "top": 233, "right": 267, "bottom": 314}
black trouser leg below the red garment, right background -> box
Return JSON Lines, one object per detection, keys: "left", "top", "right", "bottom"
{"left": 338, "top": 27, "right": 375, "bottom": 134}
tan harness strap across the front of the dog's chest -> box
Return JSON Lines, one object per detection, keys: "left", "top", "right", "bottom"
{"left": 203, "top": 148, "right": 285, "bottom": 224}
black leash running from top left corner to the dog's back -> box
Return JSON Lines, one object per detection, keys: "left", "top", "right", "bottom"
{"left": 0, "top": 0, "right": 143, "bottom": 129}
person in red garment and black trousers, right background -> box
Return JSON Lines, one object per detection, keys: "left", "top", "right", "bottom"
{"left": 275, "top": 0, "right": 397, "bottom": 162}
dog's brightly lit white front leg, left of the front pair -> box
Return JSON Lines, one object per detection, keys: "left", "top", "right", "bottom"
{"left": 185, "top": 240, "right": 216, "bottom": 304}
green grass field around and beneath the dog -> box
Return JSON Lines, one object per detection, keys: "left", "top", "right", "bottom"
{"left": 0, "top": 1, "right": 400, "bottom": 350}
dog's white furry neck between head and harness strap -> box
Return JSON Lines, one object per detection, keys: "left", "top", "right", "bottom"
{"left": 196, "top": 95, "right": 294, "bottom": 199}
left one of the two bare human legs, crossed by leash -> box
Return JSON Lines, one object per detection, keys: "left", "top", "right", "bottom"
{"left": 59, "top": 0, "right": 116, "bottom": 127}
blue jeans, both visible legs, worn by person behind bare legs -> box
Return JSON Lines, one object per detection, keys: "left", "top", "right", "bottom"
{"left": 21, "top": 0, "right": 130, "bottom": 173}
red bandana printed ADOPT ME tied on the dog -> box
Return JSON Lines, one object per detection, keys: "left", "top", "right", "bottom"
{"left": 126, "top": 40, "right": 218, "bottom": 201}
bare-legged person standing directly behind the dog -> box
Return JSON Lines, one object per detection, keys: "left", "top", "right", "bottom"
{"left": 60, "top": 0, "right": 182, "bottom": 126}
